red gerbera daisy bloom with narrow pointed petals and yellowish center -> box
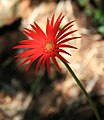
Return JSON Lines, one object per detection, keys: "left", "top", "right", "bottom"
{"left": 13, "top": 13, "right": 80, "bottom": 74}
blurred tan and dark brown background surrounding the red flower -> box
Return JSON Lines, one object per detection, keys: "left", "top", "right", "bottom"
{"left": 0, "top": 0, "right": 104, "bottom": 120}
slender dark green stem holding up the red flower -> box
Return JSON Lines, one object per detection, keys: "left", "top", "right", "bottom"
{"left": 62, "top": 61, "right": 101, "bottom": 120}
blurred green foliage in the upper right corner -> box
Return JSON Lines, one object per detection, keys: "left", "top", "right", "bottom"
{"left": 77, "top": 0, "right": 104, "bottom": 35}
